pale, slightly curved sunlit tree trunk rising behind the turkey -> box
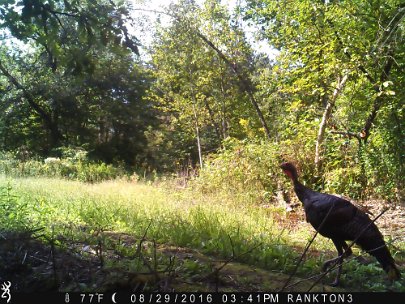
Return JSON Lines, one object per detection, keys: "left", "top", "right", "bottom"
{"left": 315, "top": 74, "right": 348, "bottom": 174}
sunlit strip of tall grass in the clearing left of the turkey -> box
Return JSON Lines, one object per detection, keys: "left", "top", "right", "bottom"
{"left": 0, "top": 178, "right": 309, "bottom": 269}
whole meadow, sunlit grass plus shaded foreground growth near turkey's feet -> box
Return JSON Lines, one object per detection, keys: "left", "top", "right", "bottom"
{"left": 0, "top": 176, "right": 405, "bottom": 291}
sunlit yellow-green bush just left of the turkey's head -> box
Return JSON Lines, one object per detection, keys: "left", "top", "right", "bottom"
{"left": 194, "top": 138, "right": 280, "bottom": 199}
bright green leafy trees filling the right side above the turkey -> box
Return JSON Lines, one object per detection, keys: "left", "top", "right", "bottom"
{"left": 241, "top": 1, "right": 404, "bottom": 200}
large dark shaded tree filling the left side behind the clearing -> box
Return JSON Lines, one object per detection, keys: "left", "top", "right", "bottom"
{"left": 0, "top": 1, "right": 155, "bottom": 165}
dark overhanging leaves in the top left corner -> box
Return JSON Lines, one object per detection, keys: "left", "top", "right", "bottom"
{"left": 0, "top": 0, "right": 138, "bottom": 71}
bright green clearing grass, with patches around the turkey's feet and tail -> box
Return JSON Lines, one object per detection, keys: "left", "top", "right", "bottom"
{"left": 0, "top": 177, "right": 405, "bottom": 291}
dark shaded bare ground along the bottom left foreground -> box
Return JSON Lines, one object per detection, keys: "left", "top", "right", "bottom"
{"left": 0, "top": 233, "right": 340, "bottom": 293}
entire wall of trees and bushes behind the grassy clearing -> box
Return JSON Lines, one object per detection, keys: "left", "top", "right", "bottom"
{"left": 0, "top": 0, "right": 405, "bottom": 199}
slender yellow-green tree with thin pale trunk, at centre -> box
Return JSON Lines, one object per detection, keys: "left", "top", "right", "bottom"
{"left": 148, "top": 1, "right": 255, "bottom": 170}
